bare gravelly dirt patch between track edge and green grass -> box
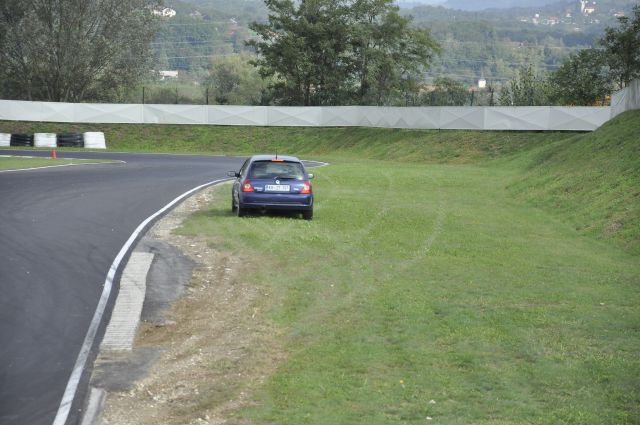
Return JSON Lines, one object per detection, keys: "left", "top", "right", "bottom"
{"left": 97, "top": 184, "right": 283, "bottom": 425}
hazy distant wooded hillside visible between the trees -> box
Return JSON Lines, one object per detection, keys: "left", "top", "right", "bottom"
{"left": 154, "top": 0, "right": 638, "bottom": 87}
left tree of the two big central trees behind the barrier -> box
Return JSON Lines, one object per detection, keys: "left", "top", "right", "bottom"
{"left": 250, "top": 0, "right": 348, "bottom": 105}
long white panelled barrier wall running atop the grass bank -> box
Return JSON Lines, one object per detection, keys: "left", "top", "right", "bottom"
{"left": 0, "top": 100, "right": 611, "bottom": 131}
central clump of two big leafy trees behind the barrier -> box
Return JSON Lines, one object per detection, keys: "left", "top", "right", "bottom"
{"left": 251, "top": 0, "right": 438, "bottom": 105}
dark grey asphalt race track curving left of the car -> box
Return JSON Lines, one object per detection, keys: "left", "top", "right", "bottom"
{"left": 0, "top": 150, "right": 243, "bottom": 425}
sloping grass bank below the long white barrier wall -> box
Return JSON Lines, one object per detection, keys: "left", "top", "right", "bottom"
{"left": 0, "top": 111, "right": 640, "bottom": 253}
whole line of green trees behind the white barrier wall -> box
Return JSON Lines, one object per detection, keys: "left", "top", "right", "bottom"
{"left": 0, "top": 0, "right": 640, "bottom": 106}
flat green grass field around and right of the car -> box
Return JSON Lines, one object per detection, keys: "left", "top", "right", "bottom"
{"left": 183, "top": 161, "right": 640, "bottom": 424}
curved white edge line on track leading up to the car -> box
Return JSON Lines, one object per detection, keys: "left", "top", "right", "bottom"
{"left": 53, "top": 179, "right": 231, "bottom": 425}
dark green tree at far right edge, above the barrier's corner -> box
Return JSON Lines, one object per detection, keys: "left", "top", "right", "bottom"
{"left": 599, "top": 5, "right": 640, "bottom": 88}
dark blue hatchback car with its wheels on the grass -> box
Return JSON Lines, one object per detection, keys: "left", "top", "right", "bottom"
{"left": 229, "top": 155, "right": 313, "bottom": 220}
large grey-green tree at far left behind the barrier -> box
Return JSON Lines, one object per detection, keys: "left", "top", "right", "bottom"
{"left": 0, "top": 0, "right": 157, "bottom": 102}
